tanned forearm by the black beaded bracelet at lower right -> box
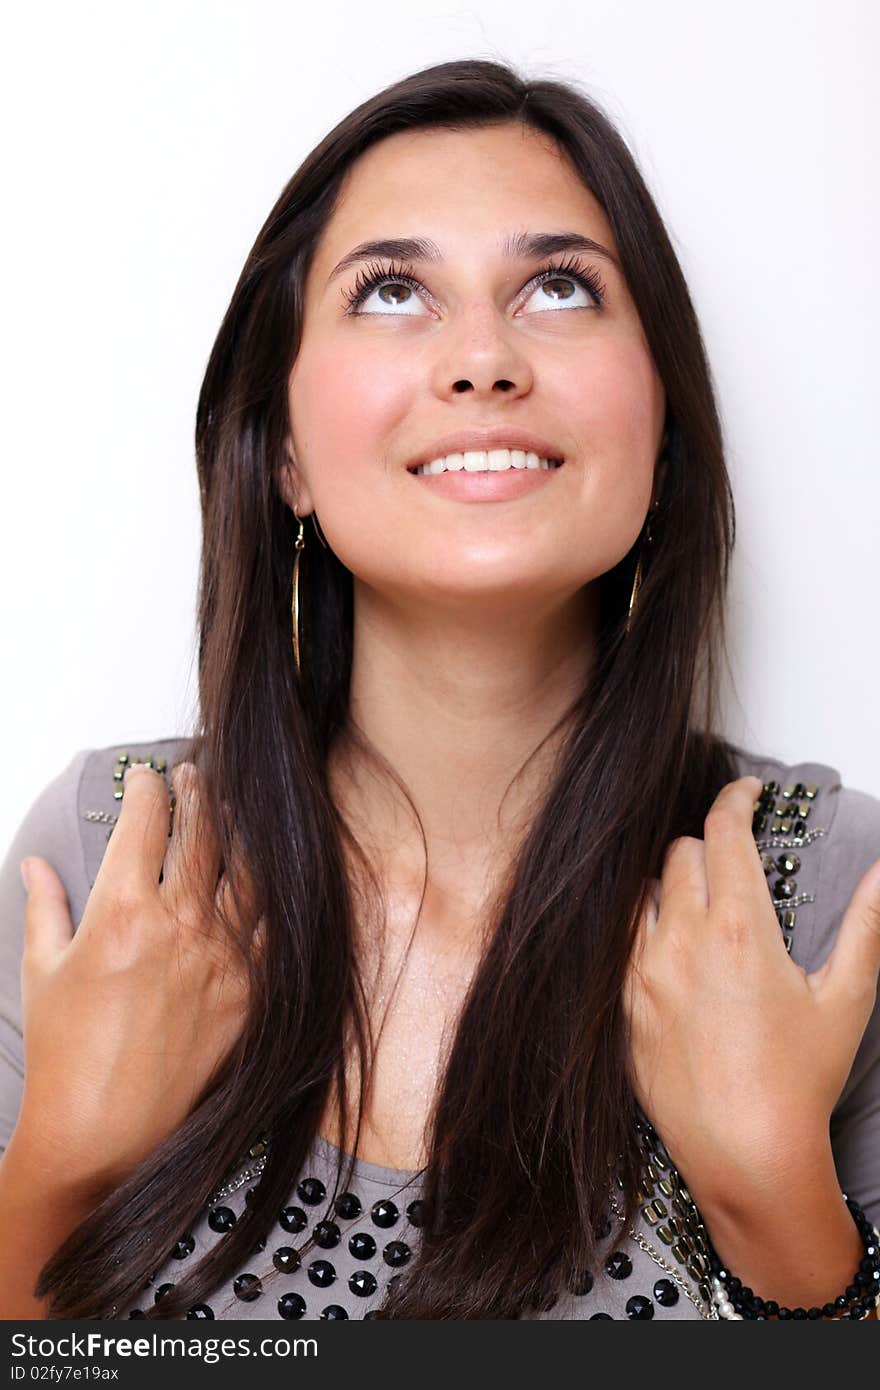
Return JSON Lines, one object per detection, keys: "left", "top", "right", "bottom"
{"left": 699, "top": 1143, "right": 865, "bottom": 1309}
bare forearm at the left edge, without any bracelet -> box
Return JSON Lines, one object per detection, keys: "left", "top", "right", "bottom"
{"left": 0, "top": 1134, "right": 99, "bottom": 1321}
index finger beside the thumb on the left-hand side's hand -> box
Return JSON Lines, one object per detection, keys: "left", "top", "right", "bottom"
{"left": 96, "top": 763, "right": 171, "bottom": 892}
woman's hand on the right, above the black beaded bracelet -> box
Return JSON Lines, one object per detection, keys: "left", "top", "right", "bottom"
{"left": 624, "top": 777, "right": 880, "bottom": 1201}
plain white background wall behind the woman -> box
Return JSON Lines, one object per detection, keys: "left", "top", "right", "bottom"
{"left": 0, "top": 0, "right": 880, "bottom": 844}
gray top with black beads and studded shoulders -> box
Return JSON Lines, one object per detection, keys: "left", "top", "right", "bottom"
{"left": 0, "top": 738, "right": 880, "bottom": 1319}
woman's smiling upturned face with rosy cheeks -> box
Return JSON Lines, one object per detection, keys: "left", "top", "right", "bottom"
{"left": 284, "top": 122, "right": 665, "bottom": 609}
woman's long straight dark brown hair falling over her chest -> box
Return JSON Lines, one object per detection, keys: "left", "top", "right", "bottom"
{"left": 38, "top": 60, "right": 737, "bottom": 1318}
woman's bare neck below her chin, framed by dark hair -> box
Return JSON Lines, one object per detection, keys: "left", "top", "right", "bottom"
{"left": 331, "top": 581, "right": 598, "bottom": 919}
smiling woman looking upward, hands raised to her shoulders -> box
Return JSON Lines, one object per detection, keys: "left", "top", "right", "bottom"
{"left": 0, "top": 61, "right": 880, "bottom": 1318}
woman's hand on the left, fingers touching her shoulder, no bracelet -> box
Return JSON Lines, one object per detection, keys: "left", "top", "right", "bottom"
{"left": 14, "top": 763, "right": 257, "bottom": 1200}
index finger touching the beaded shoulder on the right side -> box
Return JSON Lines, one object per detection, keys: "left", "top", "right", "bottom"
{"left": 703, "top": 777, "right": 769, "bottom": 909}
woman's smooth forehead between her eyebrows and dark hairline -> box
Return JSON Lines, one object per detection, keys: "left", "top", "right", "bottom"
{"left": 316, "top": 122, "right": 614, "bottom": 274}
